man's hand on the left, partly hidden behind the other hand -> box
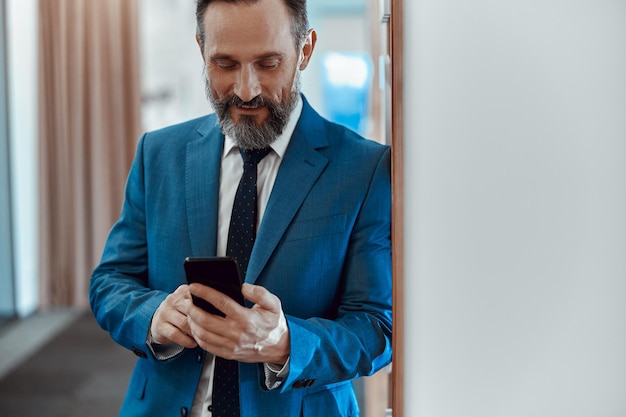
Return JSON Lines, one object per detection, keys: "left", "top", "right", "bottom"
{"left": 150, "top": 285, "right": 198, "bottom": 348}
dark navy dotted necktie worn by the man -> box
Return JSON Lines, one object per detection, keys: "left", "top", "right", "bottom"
{"left": 212, "top": 148, "right": 270, "bottom": 417}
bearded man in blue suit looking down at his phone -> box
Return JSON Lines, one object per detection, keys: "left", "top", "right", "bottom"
{"left": 90, "top": 0, "right": 391, "bottom": 417}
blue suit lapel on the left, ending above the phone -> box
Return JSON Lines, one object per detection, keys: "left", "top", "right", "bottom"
{"left": 185, "top": 119, "right": 224, "bottom": 256}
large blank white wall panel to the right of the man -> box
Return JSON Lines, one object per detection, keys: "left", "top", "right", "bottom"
{"left": 404, "top": 0, "right": 626, "bottom": 417}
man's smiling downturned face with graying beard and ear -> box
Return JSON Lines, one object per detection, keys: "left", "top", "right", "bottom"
{"left": 202, "top": 0, "right": 315, "bottom": 148}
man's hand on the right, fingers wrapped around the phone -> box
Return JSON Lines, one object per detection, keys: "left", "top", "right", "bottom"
{"left": 186, "top": 284, "right": 290, "bottom": 365}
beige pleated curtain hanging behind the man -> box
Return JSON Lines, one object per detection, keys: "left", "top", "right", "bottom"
{"left": 39, "top": 0, "right": 141, "bottom": 308}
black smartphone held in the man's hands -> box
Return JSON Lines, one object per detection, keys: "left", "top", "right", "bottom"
{"left": 184, "top": 257, "right": 245, "bottom": 317}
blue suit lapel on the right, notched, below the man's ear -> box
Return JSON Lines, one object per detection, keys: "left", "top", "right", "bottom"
{"left": 246, "top": 100, "right": 328, "bottom": 283}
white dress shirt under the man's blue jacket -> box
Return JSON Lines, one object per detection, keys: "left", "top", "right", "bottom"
{"left": 190, "top": 97, "right": 303, "bottom": 417}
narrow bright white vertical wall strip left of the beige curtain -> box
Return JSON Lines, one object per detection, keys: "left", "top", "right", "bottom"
{"left": 5, "top": 0, "right": 39, "bottom": 316}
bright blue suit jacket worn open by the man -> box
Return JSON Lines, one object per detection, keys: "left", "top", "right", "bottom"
{"left": 90, "top": 96, "right": 391, "bottom": 417}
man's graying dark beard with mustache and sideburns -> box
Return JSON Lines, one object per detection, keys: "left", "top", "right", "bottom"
{"left": 204, "top": 67, "right": 301, "bottom": 150}
